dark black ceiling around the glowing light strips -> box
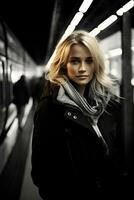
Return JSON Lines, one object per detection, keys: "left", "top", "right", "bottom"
{"left": 0, "top": 0, "right": 133, "bottom": 64}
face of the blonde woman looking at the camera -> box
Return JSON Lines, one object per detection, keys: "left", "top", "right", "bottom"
{"left": 66, "top": 44, "right": 94, "bottom": 86}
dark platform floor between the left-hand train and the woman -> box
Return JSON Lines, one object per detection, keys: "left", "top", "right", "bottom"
{"left": 0, "top": 103, "right": 42, "bottom": 200}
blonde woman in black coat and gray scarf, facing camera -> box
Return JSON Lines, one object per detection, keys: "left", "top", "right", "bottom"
{"left": 31, "top": 31, "right": 123, "bottom": 200}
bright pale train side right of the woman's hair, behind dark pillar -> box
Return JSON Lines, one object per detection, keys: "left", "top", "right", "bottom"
{"left": 100, "top": 29, "right": 134, "bottom": 98}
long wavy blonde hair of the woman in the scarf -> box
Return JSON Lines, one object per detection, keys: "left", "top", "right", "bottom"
{"left": 47, "top": 30, "right": 119, "bottom": 101}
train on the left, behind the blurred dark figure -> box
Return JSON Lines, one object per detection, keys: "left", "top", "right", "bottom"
{"left": 0, "top": 20, "right": 37, "bottom": 174}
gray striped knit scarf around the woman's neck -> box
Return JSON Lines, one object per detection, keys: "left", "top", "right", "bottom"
{"left": 57, "top": 81, "right": 110, "bottom": 154}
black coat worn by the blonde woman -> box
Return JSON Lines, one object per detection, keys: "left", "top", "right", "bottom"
{"left": 31, "top": 81, "right": 123, "bottom": 200}
